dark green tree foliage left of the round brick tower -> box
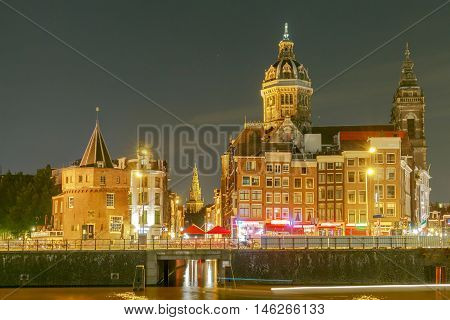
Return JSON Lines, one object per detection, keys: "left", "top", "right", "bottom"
{"left": 0, "top": 166, "right": 59, "bottom": 236}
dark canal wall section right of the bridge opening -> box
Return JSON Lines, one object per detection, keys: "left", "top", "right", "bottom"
{"left": 227, "top": 249, "right": 450, "bottom": 285}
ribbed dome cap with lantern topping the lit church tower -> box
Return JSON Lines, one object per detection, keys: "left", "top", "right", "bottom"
{"left": 263, "top": 23, "right": 311, "bottom": 82}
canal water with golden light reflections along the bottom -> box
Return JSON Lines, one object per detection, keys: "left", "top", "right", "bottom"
{"left": 0, "top": 260, "right": 450, "bottom": 300}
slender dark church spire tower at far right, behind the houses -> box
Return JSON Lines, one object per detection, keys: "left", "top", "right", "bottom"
{"left": 391, "top": 44, "right": 427, "bottom": 169}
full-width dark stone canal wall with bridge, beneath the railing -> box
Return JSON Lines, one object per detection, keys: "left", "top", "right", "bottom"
{"left": 0, "top": 249, "right": 450, "bottom": 287}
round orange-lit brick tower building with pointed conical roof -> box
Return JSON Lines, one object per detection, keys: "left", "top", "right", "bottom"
{"left": 52, "top": 121, "right": 130, "bottom": 239}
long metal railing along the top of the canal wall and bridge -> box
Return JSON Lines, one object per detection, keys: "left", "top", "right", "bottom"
{"left": 0, "top": 236, "right": 450, "bottom": 252}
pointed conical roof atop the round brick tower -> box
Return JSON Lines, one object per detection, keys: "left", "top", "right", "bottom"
{"left": 80, "top": 120, "right": 114, "bottom": 168}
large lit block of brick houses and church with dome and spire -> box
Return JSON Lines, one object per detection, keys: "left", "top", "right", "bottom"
{"left": 221, "top": 25, "right": 430, "bottom": 239}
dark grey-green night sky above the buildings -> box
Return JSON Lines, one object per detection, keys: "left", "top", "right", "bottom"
{"left": 0, "top": 0, "right": 450, "bottom": 201}
